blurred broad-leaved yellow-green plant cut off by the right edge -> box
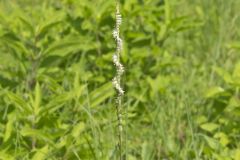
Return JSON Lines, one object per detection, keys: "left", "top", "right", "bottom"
{"left": 201, "top": 63, "right": 240, "bottom": 159}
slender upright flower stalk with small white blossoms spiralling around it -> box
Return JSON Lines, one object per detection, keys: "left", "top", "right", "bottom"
{"left": 113, "top": 0, "right": 124, "bottom": 160}
